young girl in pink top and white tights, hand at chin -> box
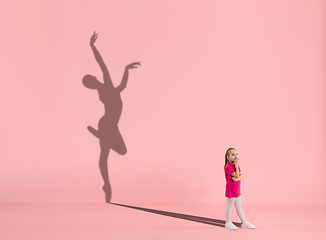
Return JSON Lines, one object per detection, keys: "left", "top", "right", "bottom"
{"left": 224, "top": 148, "right": 255, "bottom": 230}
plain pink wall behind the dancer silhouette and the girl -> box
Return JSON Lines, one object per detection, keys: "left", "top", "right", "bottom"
{"left": 0, "top": 0, "right": 326, "bottom": 203}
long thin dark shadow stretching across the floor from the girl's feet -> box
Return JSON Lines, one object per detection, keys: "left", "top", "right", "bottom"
{"left": 111, "top": 203, "right": 241, "bottom": 228}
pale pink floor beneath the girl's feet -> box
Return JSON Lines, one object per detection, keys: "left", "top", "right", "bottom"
{"left": 0, "top": 203, "right": 326, "bottom": 240}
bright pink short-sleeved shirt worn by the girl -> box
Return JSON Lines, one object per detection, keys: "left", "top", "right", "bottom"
{"left": 224, "top": 161, "right": 241, "bottom": 197}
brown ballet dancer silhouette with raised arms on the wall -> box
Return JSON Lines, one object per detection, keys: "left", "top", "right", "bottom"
{"left": 83, "top": 32, "right": 140, "bottom": 203}
